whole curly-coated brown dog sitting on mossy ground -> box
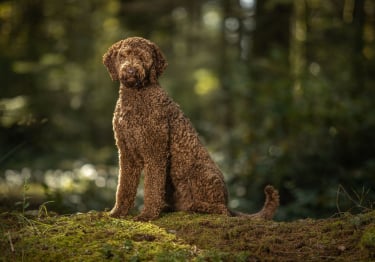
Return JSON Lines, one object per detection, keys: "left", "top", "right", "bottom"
{"left": 103, "top": 37, "right": 279, "bottom": 221}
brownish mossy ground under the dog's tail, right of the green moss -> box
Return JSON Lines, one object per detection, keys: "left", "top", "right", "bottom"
{"left": 155, "top": 212, "right": 375, "bottom": 261}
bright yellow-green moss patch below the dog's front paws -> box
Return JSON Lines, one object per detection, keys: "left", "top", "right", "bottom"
{"left": 5, "top": 213, "right": 192, "bottom": 261}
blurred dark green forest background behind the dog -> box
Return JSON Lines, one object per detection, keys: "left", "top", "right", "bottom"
{"left": 0, "top": 0, "right": 375, "bottom": 220}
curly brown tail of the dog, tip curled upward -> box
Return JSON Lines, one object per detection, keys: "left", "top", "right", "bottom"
{"left": 231, "top": 185, "right": 280, "bottom": 220}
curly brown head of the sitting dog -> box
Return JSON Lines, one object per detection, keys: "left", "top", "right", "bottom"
{"left": 103, "top": 37, "right": 167, "bottom": 88}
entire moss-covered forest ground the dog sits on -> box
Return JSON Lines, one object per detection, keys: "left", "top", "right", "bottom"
{"left": 0, "top": 208, "right": 375, "bottom": 261}
